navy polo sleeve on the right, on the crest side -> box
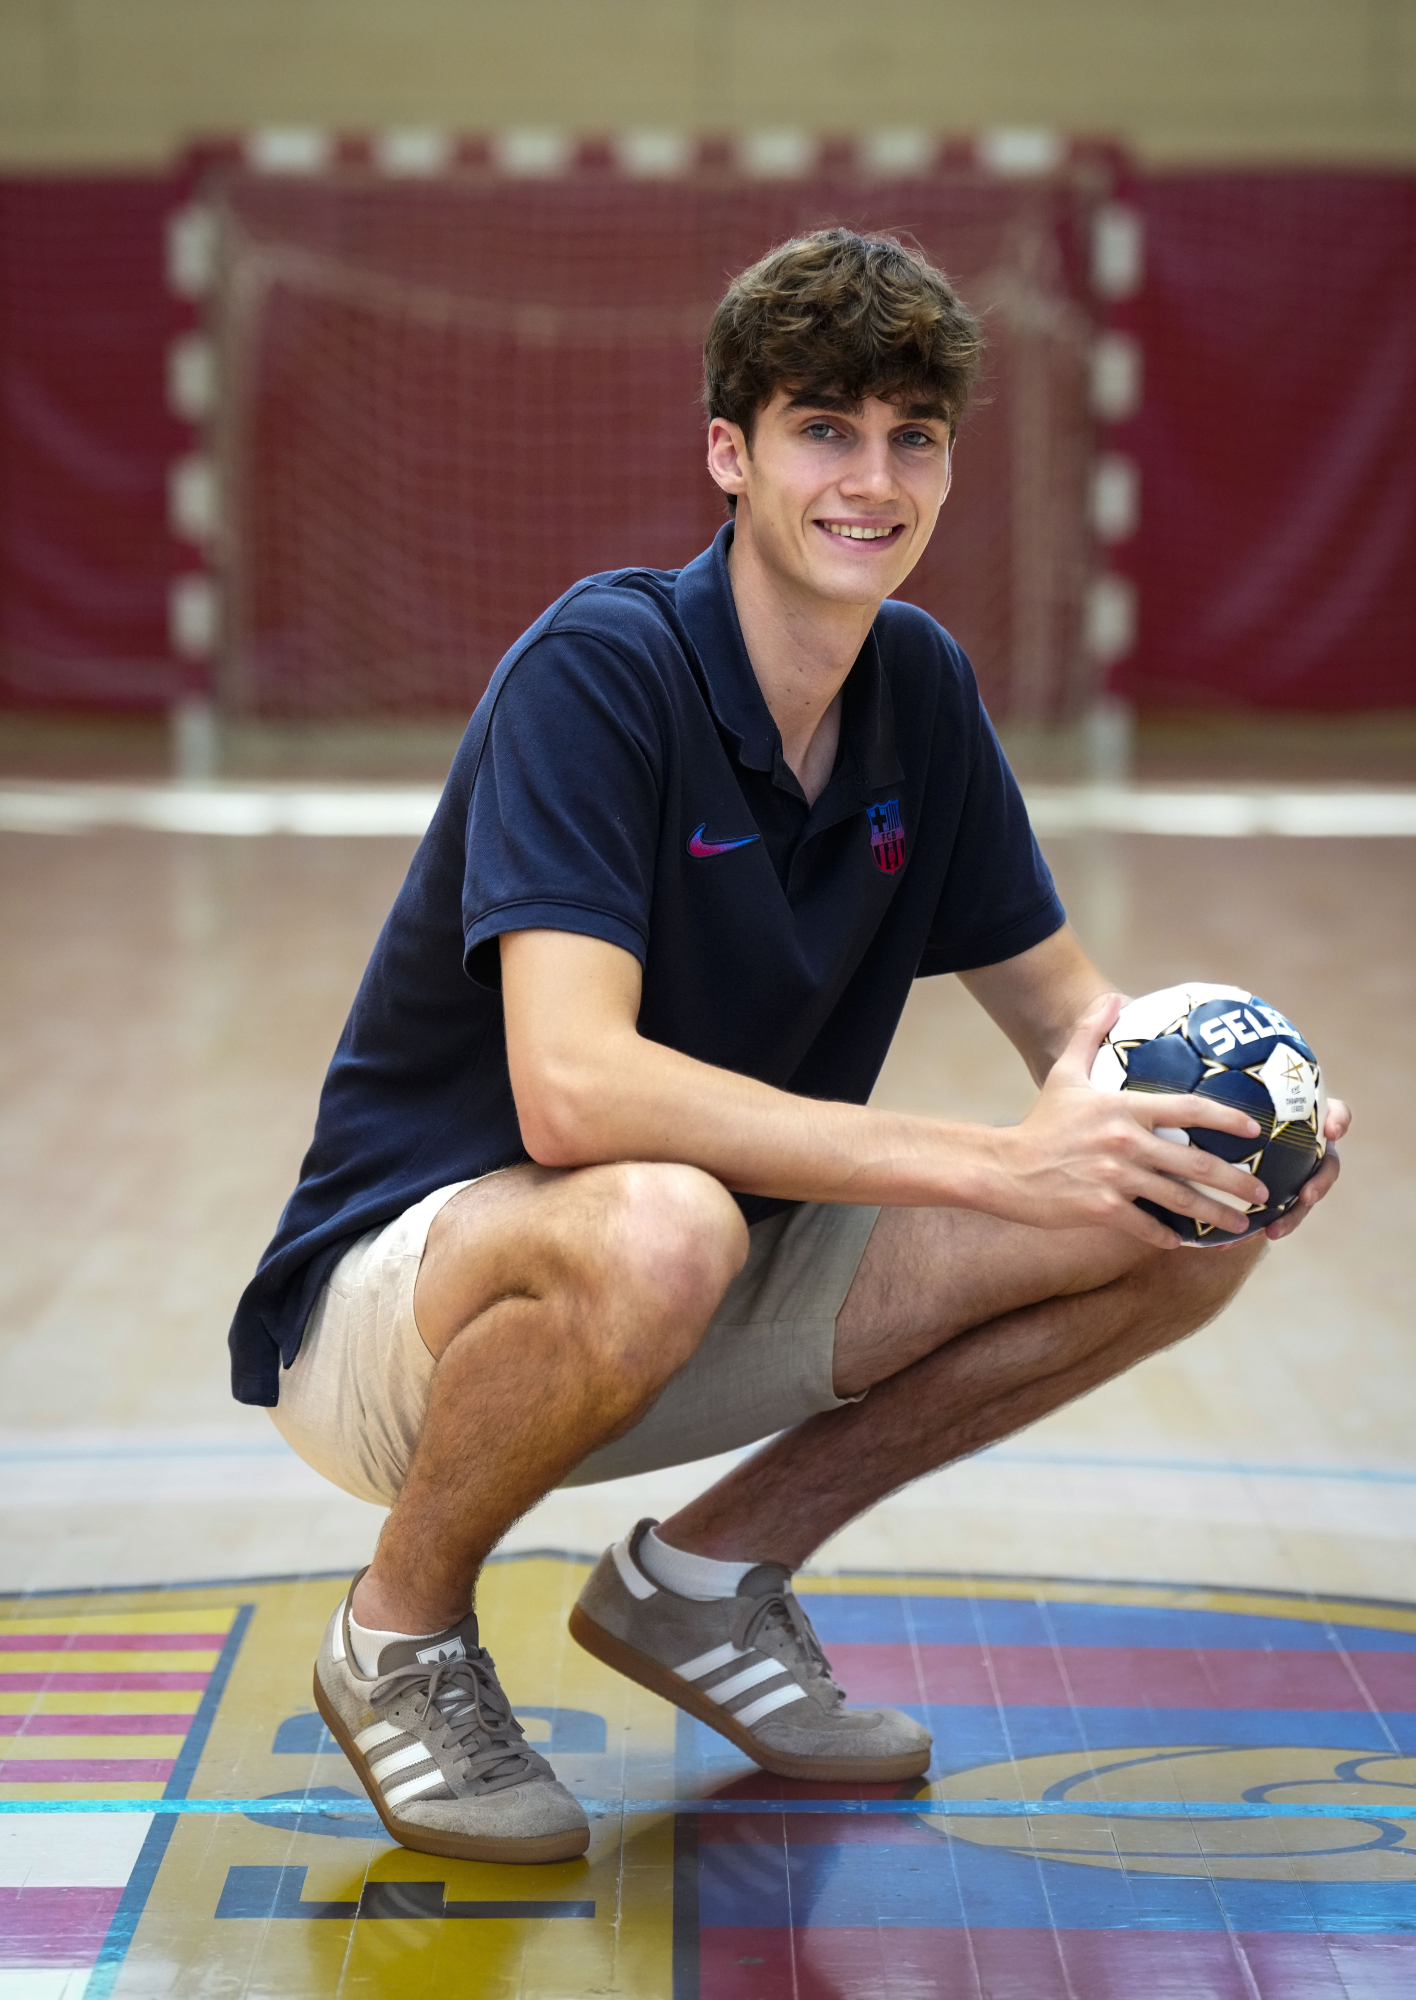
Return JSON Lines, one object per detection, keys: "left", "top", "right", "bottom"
{"left": 920, "top": 696, "right": 1066, "bottom": 974}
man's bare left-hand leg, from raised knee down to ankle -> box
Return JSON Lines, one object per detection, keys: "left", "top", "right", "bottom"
{"left": 354, "top": 1166, "right": 748, "bottom": 1632}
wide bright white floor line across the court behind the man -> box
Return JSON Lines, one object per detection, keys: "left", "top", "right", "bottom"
{"left": 0, "top": 778, "right": 1416, "bottom": 840}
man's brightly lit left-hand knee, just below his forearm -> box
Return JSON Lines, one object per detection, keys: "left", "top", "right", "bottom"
{"left": 564, "top": 1162, "right": 748, "bottom": 1398}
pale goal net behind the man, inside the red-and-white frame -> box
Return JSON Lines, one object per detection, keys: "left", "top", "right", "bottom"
{"left": 199, "top": 166, "right": 1096, "bottom": 722}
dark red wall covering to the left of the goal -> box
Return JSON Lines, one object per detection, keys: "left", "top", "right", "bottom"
{"left": 0, "top": 178, "right": 182, "bottom": 708}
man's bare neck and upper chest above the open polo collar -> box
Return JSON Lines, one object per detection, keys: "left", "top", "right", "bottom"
{"left": 728, "top": 502, "right": 880, "bottom": 800}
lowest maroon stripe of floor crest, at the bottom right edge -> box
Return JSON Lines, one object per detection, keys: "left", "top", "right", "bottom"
{"left": 700, "top": 1926, "right": 1416, "bottom": 2000}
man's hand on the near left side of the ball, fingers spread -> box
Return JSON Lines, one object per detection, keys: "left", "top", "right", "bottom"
{"left": 990, "top": 994, "right": 1272, "bottom": 1250}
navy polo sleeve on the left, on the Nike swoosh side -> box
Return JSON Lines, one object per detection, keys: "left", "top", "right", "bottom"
{"left": 462, "top": 630, "right": 664, "bottom": 986}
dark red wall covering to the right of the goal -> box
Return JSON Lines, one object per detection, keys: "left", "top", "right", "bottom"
{"left": 1114, "top": 172, "right": 1416, "bottom": 710}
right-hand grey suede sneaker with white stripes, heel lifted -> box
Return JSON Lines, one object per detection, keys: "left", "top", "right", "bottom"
{"left": 570, "top": 1520, "right": 934, "bottom": 1784}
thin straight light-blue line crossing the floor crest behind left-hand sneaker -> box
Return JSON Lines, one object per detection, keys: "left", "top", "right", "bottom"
{"left": 0, "top": 1798, "right": 1416, "bottom": 1826}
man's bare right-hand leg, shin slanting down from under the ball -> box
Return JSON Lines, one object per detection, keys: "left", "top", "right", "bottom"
{"left": 660, "top": 1210, "right": 1264, "bottom": 1568}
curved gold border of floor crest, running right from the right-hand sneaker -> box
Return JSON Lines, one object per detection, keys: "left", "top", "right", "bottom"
{"left": 794, "top": 1574, "right": 1416, "bottom": 1632}
